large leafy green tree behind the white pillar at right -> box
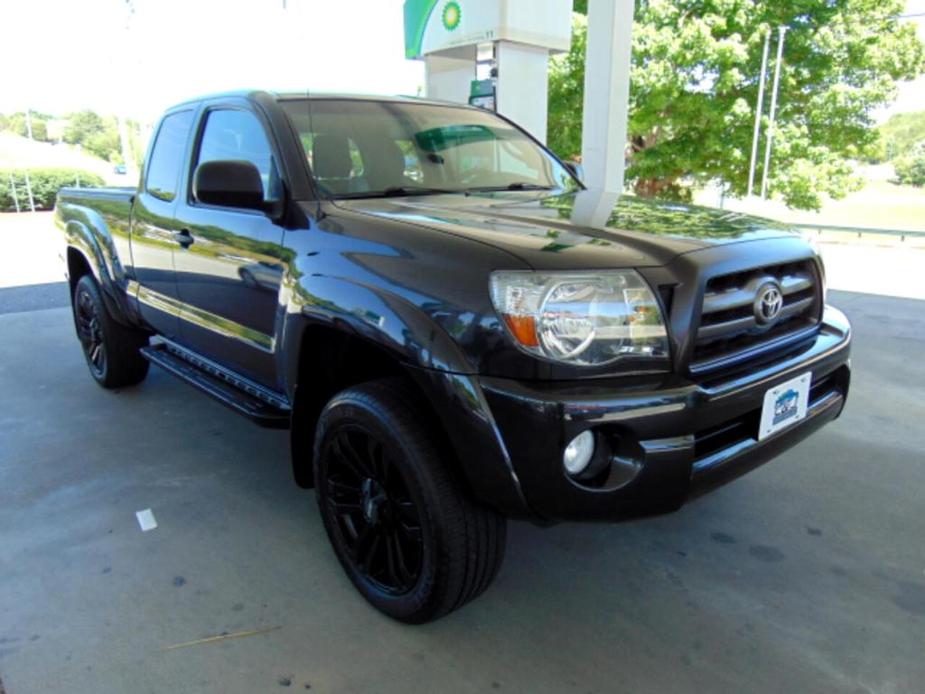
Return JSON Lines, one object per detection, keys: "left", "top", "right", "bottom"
{"left": 549, "top": 0, "right": 925, "bottom": 209}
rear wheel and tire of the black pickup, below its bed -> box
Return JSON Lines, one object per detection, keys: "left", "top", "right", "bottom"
{"left": 72, "top": 275, "right": 148, "bottom": 388}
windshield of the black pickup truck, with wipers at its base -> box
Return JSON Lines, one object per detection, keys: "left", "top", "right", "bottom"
{"left": 281, "top": 99, "right": 579, "bottom": 198}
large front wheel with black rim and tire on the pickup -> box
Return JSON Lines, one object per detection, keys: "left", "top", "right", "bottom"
{"left": 314, "top": 380, "right": 506, "bottom": 624}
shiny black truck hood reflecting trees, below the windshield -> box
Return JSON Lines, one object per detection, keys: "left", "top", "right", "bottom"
{"left": 337, "top": 190, "right": 799, "bottom": 270}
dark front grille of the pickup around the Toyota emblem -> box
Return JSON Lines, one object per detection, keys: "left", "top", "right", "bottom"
{"left": 691, "top": 260, "right": 820, "bottom": 372}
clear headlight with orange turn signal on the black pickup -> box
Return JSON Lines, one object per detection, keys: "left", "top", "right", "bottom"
{"left": 491, "top": 270, "right": 668, "bottom": 366}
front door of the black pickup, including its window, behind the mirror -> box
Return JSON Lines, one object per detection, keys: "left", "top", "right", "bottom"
{"left": 174, "top": 101, "right": 283, "bottom": 388}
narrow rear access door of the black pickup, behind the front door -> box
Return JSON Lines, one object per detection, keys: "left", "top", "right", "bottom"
{"left": 131, "top": 108, "right": 195, "bottom": 338}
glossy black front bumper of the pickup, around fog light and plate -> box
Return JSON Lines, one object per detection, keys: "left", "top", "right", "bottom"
{"left": 480, "top": 307, "right": 851, "bottom": 521}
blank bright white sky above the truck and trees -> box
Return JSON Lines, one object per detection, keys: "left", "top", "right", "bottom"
{"left": 0, "top": 0, "right": 925, "bottom": 121}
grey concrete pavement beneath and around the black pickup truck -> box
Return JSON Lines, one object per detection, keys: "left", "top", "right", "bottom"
{"left": 0, "top": 292, "right": 925, "bottom": 694}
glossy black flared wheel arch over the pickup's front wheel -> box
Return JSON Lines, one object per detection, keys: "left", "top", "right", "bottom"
{"left": 280, "top": 278, "right": 533, "bottom": 518}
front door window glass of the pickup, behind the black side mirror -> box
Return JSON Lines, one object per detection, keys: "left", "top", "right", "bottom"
{"left": 196, "top": 109, "right": 281, "bottom": 201}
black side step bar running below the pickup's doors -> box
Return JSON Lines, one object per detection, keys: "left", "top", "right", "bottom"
{"left": 141, "top": 338, "right": 291, "bottom": 429}
